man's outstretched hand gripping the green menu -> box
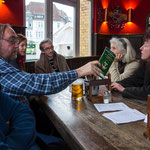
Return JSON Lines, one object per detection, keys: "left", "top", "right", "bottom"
{"left": 76, "top": 60, "right": 101, "bottom": 78}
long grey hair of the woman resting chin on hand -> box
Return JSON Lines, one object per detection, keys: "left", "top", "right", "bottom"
{"left": 110, "top": 38, "right": 136, "bottom": 63}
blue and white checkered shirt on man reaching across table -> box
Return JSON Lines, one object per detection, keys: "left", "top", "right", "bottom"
{"left": 0, "top": 57, "right": 77, "bottom": 104}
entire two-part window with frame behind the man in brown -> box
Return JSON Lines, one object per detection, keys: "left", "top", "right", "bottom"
{"left": 25, "top": 0, "right": 79, "bottom": 60}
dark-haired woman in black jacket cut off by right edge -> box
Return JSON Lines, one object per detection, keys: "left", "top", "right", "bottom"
{"left": 111, "top": 29, "right": 150, "bottom": 100}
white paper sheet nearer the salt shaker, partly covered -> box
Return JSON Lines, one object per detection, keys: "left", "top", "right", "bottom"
{"left": 94, "top": 102, "right": 130, "bottom": 112}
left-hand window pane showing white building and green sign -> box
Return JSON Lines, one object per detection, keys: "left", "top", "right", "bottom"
{"left": 25, "top": 0, "right": 45, "bottom": 60}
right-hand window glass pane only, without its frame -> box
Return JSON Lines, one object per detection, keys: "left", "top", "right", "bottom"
{"left": 53, "top": 2, "right": 75, "bottom": 57}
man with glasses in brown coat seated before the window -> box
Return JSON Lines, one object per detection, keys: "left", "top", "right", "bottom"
{"left": 35, "top": 39, "right": 70, "bottom": 73}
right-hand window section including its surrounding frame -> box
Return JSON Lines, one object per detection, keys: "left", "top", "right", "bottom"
{"left": 46, "top": 0, "right": 79, "bottom": 57}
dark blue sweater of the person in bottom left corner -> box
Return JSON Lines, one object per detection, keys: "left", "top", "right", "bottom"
{"left": 0, "top": 92, "right": 39, "bottom": 150}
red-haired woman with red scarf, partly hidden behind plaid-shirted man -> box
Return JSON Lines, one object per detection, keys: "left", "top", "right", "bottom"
{"left": 9, "top": 34, "right": 27, "bottom": 71}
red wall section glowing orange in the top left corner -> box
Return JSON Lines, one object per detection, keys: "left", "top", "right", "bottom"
{"left": 0, "top": 0, "right": 23, "bottom": 26}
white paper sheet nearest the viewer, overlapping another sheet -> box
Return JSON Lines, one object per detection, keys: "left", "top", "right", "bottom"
{"left": 103, "top": 109, "right": 145, "bottom": 124}
